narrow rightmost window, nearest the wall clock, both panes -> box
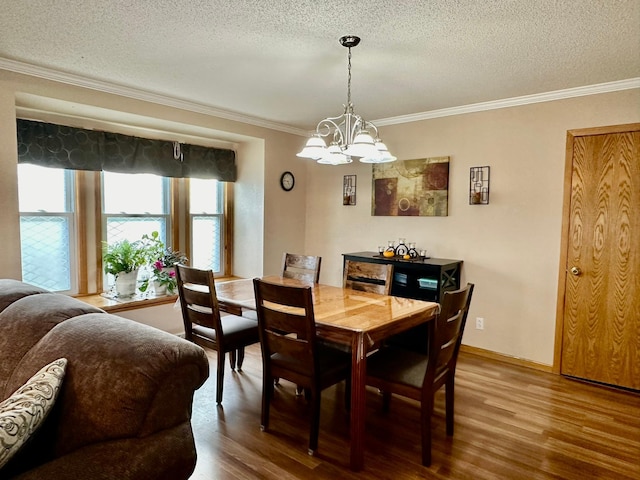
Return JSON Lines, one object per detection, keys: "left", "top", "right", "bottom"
{"left": 189, "top": 178, "right": 224, "bottom": 274}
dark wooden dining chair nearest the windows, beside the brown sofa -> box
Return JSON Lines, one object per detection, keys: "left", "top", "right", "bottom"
{"left": 176, "top": 265, "right": 260, "bottom": 404}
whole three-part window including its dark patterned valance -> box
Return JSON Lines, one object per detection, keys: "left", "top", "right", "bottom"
{"left": 17, "top": 119, "right": 236, "bottom": 294}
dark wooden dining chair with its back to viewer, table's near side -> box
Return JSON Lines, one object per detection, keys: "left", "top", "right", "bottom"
{"left": 253, "top": 278, "right": 351, "bottom": 455}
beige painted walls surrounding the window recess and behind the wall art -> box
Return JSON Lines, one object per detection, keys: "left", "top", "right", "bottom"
{"left": 0, "top": 71, "right": 640, "bottom": 365}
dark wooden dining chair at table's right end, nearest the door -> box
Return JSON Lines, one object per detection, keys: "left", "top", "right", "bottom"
{"left": 367, "top": 283, "right": 474, "bottom": 467}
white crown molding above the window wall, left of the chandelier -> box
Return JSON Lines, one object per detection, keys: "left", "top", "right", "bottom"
{"left": 0, "top": 58, "right": 307, "bottom": 136}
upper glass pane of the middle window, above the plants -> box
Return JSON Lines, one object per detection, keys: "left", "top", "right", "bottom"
{"left": 102, "top": 172, "right": 167, "bottom": 215}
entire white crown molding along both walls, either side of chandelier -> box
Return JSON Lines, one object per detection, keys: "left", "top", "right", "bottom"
{"left": 0, "top": 58, "right": 640, "bottom": 136}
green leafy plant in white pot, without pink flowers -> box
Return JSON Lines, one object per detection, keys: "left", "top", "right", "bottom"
{"left": 102, "top": 240, "right": 147, "bottom": 297}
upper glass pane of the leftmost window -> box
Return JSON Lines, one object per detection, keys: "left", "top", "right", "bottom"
{"left": 18, "top": 163, "right": 71, "bottom": 212}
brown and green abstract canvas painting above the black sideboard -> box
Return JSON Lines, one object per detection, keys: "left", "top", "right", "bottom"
{"left": 371, "top": 157, "right": 449, "bottom": 217}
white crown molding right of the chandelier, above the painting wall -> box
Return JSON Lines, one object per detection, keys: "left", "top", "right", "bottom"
{"left": 374, "top": 77, "right": 640, "bottom": 126}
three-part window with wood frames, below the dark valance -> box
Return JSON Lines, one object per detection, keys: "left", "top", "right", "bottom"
{"left": 18, "top": 169, "right": 230, "bottom": 294}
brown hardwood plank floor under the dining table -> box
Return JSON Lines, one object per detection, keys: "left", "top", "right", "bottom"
{"left": 191, "top": 345, "right": 640, "bottom": 480}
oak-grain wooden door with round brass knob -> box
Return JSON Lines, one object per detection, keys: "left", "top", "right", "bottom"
{"left": 560, "top": 124, "right": 640, "bottom": 390}
